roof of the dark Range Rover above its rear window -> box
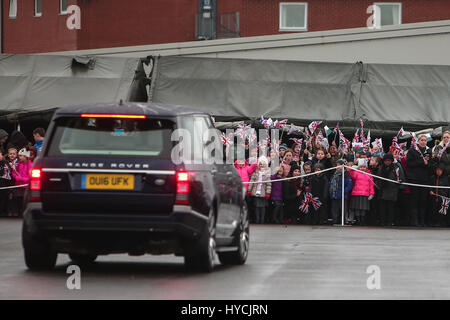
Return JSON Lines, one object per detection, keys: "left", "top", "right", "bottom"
{"left": 55, "top": 102, "right": 207, "bottom": 117}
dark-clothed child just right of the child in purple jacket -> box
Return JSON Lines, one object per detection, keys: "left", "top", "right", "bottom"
{"left": 283, "top": 164, "right": 302, "bottom": 223}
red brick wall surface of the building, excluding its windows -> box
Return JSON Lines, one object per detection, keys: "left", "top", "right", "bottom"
{"left": 3, "top": 0, "right": 450, "bottom": 53}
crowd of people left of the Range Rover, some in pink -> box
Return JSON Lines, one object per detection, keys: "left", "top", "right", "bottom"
{"left": 0, "top": 128, "right": 45, "bottom": 217}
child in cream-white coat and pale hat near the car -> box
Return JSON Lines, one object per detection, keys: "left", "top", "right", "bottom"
{"left": 248, "top": 156, "right": 272, "bottom": 223}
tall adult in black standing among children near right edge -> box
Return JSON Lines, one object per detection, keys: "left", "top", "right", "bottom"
{"left": 406, "top": 135, "right": 431, "bottom": 227}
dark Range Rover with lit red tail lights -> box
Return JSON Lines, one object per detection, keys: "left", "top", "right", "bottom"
{"left": 22, "top": 101, "right": 249, "bottom": 272}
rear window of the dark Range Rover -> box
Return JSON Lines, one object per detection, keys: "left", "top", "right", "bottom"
{"left": 48, "top": 117, "right": 174, "bottom": 159}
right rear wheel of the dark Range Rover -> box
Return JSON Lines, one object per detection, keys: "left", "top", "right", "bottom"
{"left": 184, "top": 210, "right": 216, "bottom": 272}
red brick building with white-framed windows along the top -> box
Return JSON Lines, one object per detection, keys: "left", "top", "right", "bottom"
{"left": 1, "top": 0, "right": 450, "bottom": 53}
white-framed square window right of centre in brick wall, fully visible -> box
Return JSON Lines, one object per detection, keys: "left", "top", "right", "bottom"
{"left": 280, "top": 2, "right": 308, "bottom": 31}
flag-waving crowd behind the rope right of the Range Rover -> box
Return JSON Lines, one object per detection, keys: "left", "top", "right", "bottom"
{"left": 235, "top": 131, "right": 450, "bottom": 227}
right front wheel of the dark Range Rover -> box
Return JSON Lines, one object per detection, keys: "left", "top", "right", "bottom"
{"left": 218, "top": 203, "right": 250, "bottom": 265}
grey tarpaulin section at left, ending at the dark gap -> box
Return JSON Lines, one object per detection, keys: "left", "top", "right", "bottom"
{"left": 0, "top": 55, "right": 147, "bottom": 119}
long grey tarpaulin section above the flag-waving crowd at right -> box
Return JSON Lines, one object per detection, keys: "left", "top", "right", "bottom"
{"left": 151, "top": 57, "right": 450, "bottom": 132}
